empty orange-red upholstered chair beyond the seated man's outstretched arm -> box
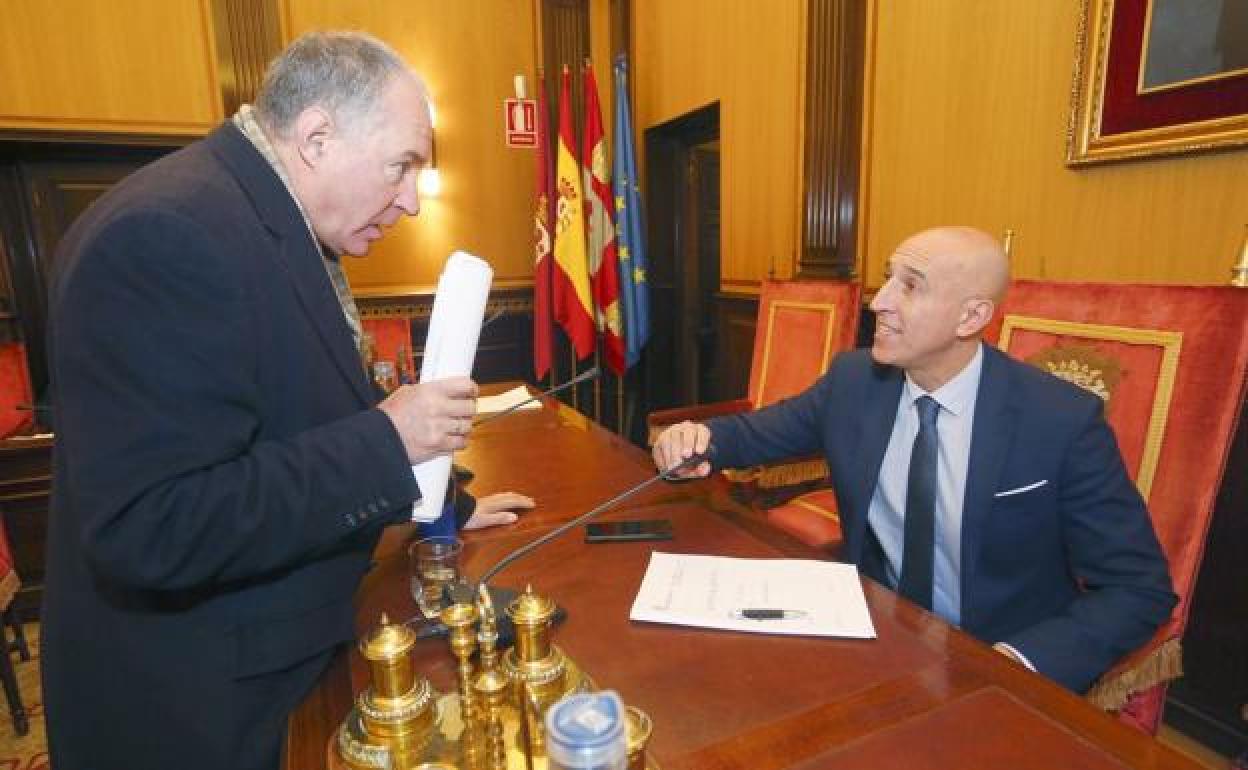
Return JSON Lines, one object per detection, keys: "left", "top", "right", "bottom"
{"left": 648, "top": 281, "right": 862, "bottom": 545}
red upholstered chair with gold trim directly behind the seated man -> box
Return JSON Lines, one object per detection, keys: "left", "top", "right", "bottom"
{"left": 988, "top": 281, "right": 1248, "bottom": 733}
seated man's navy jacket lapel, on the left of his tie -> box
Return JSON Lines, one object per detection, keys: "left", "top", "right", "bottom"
{"left": 845, "top": 363, "right": 905, "bottom": 563}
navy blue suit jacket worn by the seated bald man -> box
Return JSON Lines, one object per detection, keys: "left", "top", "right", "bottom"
{"left": 709, "top": 346, "right": 1177, "bottom": 691}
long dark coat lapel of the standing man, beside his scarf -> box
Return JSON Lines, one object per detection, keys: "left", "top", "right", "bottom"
{"left": 206, "top": 122, "right": 376, "bottom": 407}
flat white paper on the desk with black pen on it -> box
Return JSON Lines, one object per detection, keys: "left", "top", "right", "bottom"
{"left": 629, "top": 552, "right": 875, "bottom": 639}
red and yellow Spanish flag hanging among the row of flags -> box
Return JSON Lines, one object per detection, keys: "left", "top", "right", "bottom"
{"left": 554, "top": 66, "right": 594, "bottom": 359}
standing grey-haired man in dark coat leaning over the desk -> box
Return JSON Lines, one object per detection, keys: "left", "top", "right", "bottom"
{"left": 42, "top": 32, "right": 477, "bottom": 770}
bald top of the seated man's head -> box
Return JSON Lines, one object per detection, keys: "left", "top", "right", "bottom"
{"left": 896, "top": 226, "right": 1010, "bottom": 302}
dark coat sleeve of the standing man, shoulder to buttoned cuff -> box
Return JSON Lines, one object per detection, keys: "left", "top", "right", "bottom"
{"left": 52, "top": 211, "right": 417, "bottom": 590}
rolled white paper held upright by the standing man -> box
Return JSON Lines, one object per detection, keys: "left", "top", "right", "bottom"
{"left": 412, "top": 251, "right": 494, "bottom": 522}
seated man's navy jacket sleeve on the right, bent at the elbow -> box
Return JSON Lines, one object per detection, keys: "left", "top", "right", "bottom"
{"left": 1003, "top": 399, "right": 1177, "bottom": 693}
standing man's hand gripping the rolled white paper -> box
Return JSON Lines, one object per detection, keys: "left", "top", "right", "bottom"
{"left": 377, "top": 377, "right": 477, "bottom": 465}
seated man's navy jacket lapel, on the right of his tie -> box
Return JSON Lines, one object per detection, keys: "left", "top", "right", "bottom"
{"left": 961, "top": 344, "right": 1018, "bottom": 628}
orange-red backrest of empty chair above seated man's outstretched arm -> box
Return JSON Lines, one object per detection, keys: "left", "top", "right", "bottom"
{"left": 749, "top": 281, "right": 862, "bottom": 408}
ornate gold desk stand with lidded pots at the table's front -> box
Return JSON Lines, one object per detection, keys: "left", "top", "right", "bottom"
{"left": 327, "top": 588, "right": 659, "bottom": 770}
